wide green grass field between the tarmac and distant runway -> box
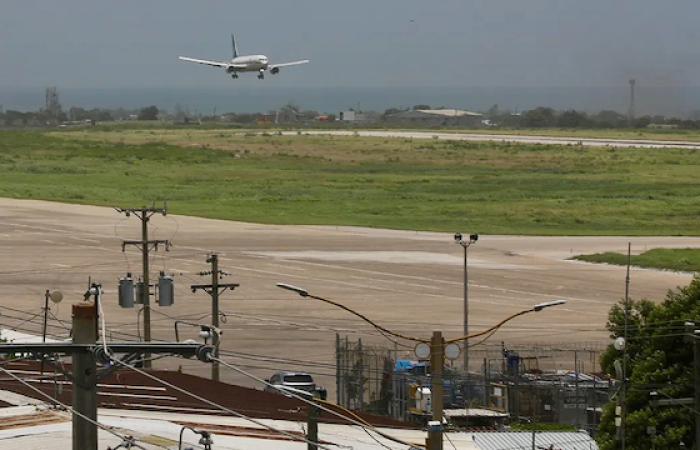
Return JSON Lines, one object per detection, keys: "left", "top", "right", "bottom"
{"left": 0, "top": 129, "right": 700, "bottom": 235}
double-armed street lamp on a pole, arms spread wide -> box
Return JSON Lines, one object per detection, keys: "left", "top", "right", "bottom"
{"left": 277, "top": 283, "right": 566, "bottom": 450}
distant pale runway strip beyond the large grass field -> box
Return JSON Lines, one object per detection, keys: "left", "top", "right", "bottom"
{"left": 282, "top": 130, "right": 700, "bottom": 149}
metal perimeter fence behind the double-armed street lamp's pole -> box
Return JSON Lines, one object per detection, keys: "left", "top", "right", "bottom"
{"left": 336, "top": 335, "right": 613, "bottom": 434}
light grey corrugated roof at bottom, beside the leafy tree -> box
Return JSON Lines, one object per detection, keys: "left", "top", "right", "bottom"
{"left": 472, "top": 431, "right": 598, "bottom": 450}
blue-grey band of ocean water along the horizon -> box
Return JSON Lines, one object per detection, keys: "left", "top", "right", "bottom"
{"left": 0, "top": 82, "right": 700, "bottom": 116}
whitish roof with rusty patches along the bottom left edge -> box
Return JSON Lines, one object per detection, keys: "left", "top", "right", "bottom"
{"left": 0, "top": 409, "right": 478, "bottom": 450}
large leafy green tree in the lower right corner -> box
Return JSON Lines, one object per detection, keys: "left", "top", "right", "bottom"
{"left": 596, "top": 275, "right": 700, "bottom": 450}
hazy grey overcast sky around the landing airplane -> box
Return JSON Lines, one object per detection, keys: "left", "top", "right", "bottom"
{"left": 0, "top": 0, "right": 700, "bottom": 87}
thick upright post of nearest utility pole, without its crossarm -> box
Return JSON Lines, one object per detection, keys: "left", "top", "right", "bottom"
{"left": 73, "top": 303, "right": 97, "bottom": 450}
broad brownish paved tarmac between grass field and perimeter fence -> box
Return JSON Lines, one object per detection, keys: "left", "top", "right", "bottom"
{"left": 0, "top": 199, "right": 700, "bottom": 394}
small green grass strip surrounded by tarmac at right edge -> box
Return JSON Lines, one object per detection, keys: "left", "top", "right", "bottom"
{"left": 570, "top": 248, "right": 700, "bottom": 272}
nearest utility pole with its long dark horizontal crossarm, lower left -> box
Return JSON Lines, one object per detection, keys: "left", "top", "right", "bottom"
{"left": 0, "top": 289, "right": 214, "bottom": 450}
